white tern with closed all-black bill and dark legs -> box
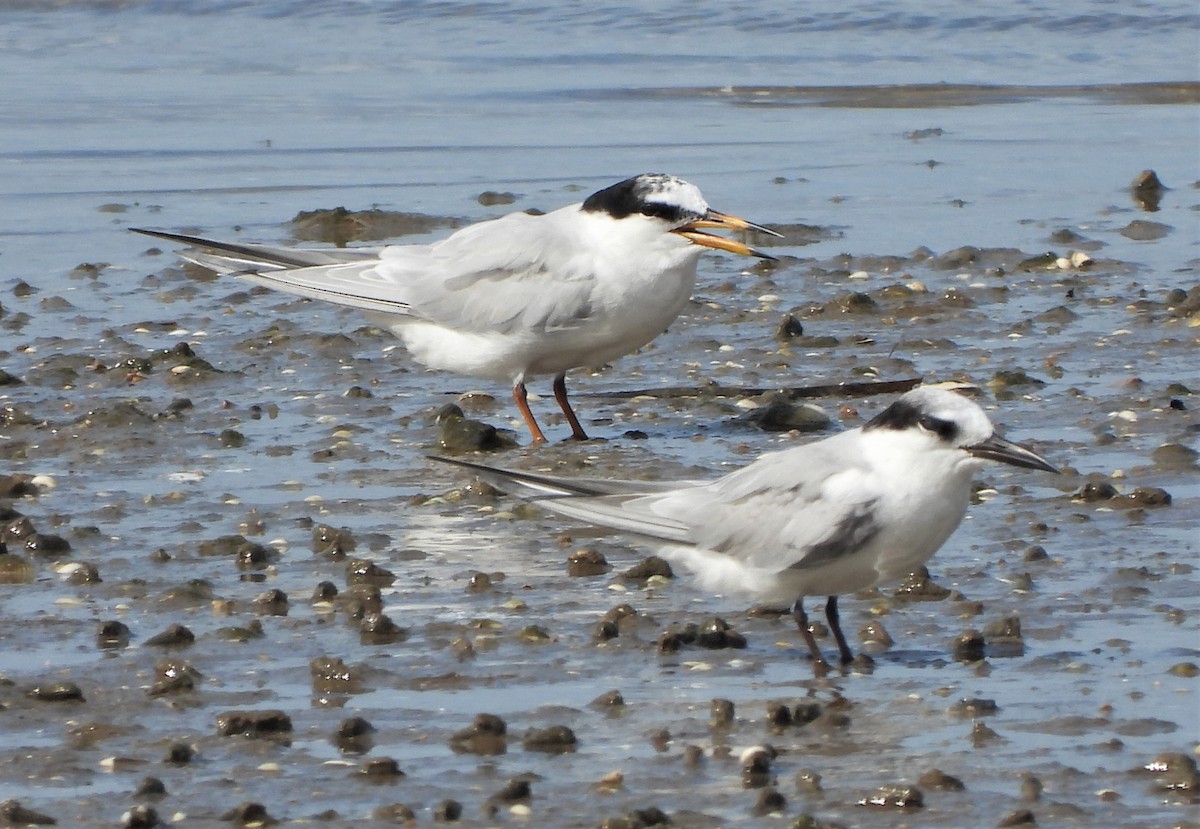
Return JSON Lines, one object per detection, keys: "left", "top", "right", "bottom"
{"left": 436, "top": 386, "right": 1058, "bottom": 667}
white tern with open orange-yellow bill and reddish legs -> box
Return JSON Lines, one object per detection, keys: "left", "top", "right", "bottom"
{"left": 130, "top": 173, "right": 780, "bottom": 443}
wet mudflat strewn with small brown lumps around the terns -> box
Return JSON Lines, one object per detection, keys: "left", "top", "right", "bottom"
{"left": 0, "top": 158, "right": 1200, "bottom": 829}
